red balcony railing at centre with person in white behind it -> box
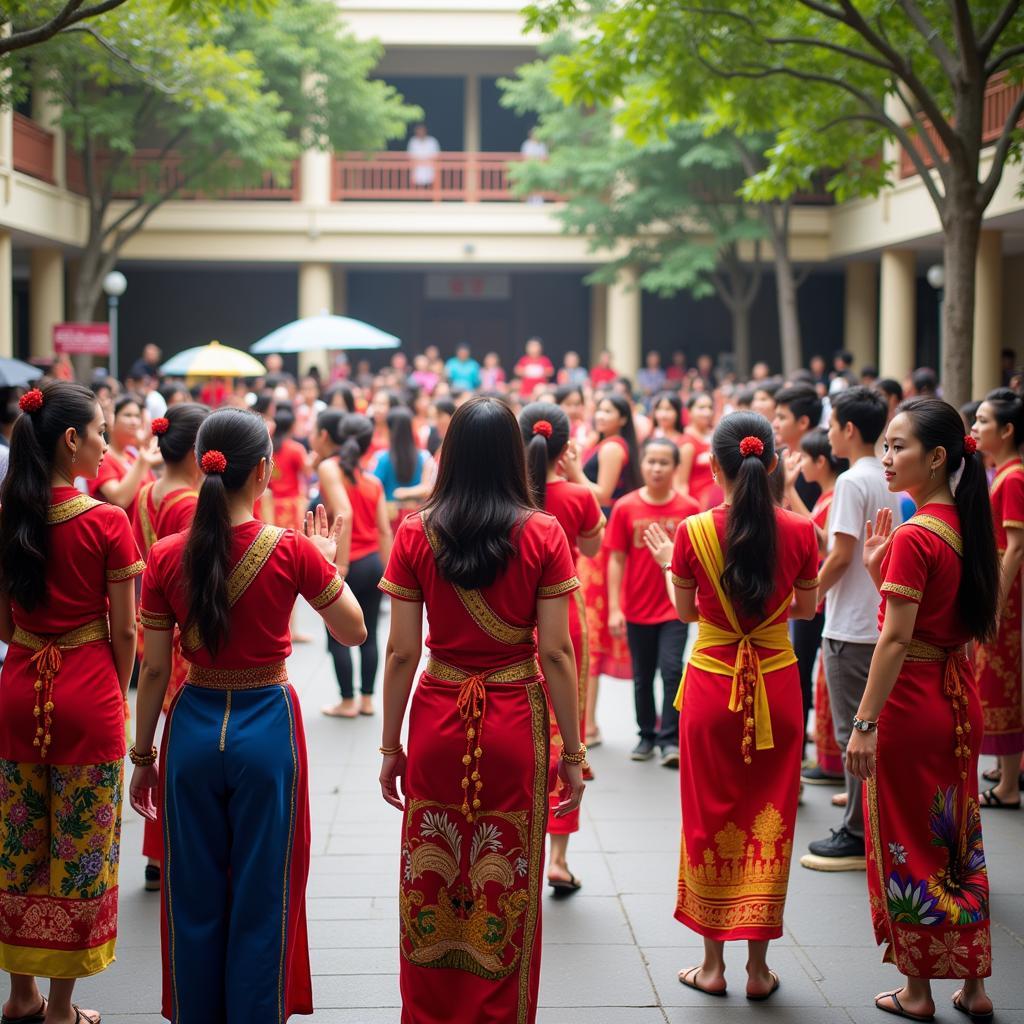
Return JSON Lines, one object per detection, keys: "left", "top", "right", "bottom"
{"left": 331, "top": 153, "right": 558, "bottom": 203}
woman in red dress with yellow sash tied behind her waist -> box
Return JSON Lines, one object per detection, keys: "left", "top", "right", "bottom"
{"left": 647, "top": 413, "right": 818, "bottom": 999}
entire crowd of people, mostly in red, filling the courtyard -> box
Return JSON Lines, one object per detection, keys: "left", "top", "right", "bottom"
{"left": 0, "top": 338, "right": 1011, "bottom": 1024}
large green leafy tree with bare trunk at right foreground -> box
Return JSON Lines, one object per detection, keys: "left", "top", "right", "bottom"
{"left": 529, "top": 0, "right": 1024, "bottom": 403}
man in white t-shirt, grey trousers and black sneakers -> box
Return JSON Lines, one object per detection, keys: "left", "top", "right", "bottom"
{"left": 800, "top": 387, "right": 901, "bottom": 871}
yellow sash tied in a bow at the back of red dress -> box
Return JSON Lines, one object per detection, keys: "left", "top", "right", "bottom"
{"left": 676, "top": 512, "right": 797, "bottom": 764}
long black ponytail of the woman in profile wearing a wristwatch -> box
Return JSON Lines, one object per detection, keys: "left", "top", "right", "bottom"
{"left": 896, "top": 396, "right": 999, "bottom": 640}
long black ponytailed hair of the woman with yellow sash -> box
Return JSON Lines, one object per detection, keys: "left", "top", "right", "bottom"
{"left": 711, "top": 413, "right": 778, "bottom": 620}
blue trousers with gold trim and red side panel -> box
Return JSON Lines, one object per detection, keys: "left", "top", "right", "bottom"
{"left": 161, "top": 685, "right": 312, "bottom": 1024}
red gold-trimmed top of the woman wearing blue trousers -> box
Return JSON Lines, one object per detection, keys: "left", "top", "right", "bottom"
{"left": 139, "top": 520, "right": 343, "bottom": 669}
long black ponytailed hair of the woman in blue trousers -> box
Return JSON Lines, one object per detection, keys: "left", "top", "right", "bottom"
{"left": 184, "top": 409, "right": 271, "bottom": 654}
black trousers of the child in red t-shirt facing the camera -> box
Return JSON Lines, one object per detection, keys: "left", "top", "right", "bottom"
{"left": 626, "top": 618, "right": 686, "bottom": 749}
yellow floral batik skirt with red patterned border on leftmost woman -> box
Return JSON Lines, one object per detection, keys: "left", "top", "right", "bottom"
{"left": 0, "top": 760, "right": 124, "bottom": 978}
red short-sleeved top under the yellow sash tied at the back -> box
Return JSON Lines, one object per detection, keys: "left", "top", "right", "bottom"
{"left": 672, "top": 505, "right": 818, "bottom": 659}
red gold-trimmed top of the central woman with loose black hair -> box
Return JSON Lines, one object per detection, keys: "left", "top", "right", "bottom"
{"left": 380, "top": 512, "right": 580, "bottom": 672}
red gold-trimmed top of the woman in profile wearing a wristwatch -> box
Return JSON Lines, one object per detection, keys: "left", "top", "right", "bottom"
{"left": 879, "top": 503, "right": 970, "bottom": 649}
